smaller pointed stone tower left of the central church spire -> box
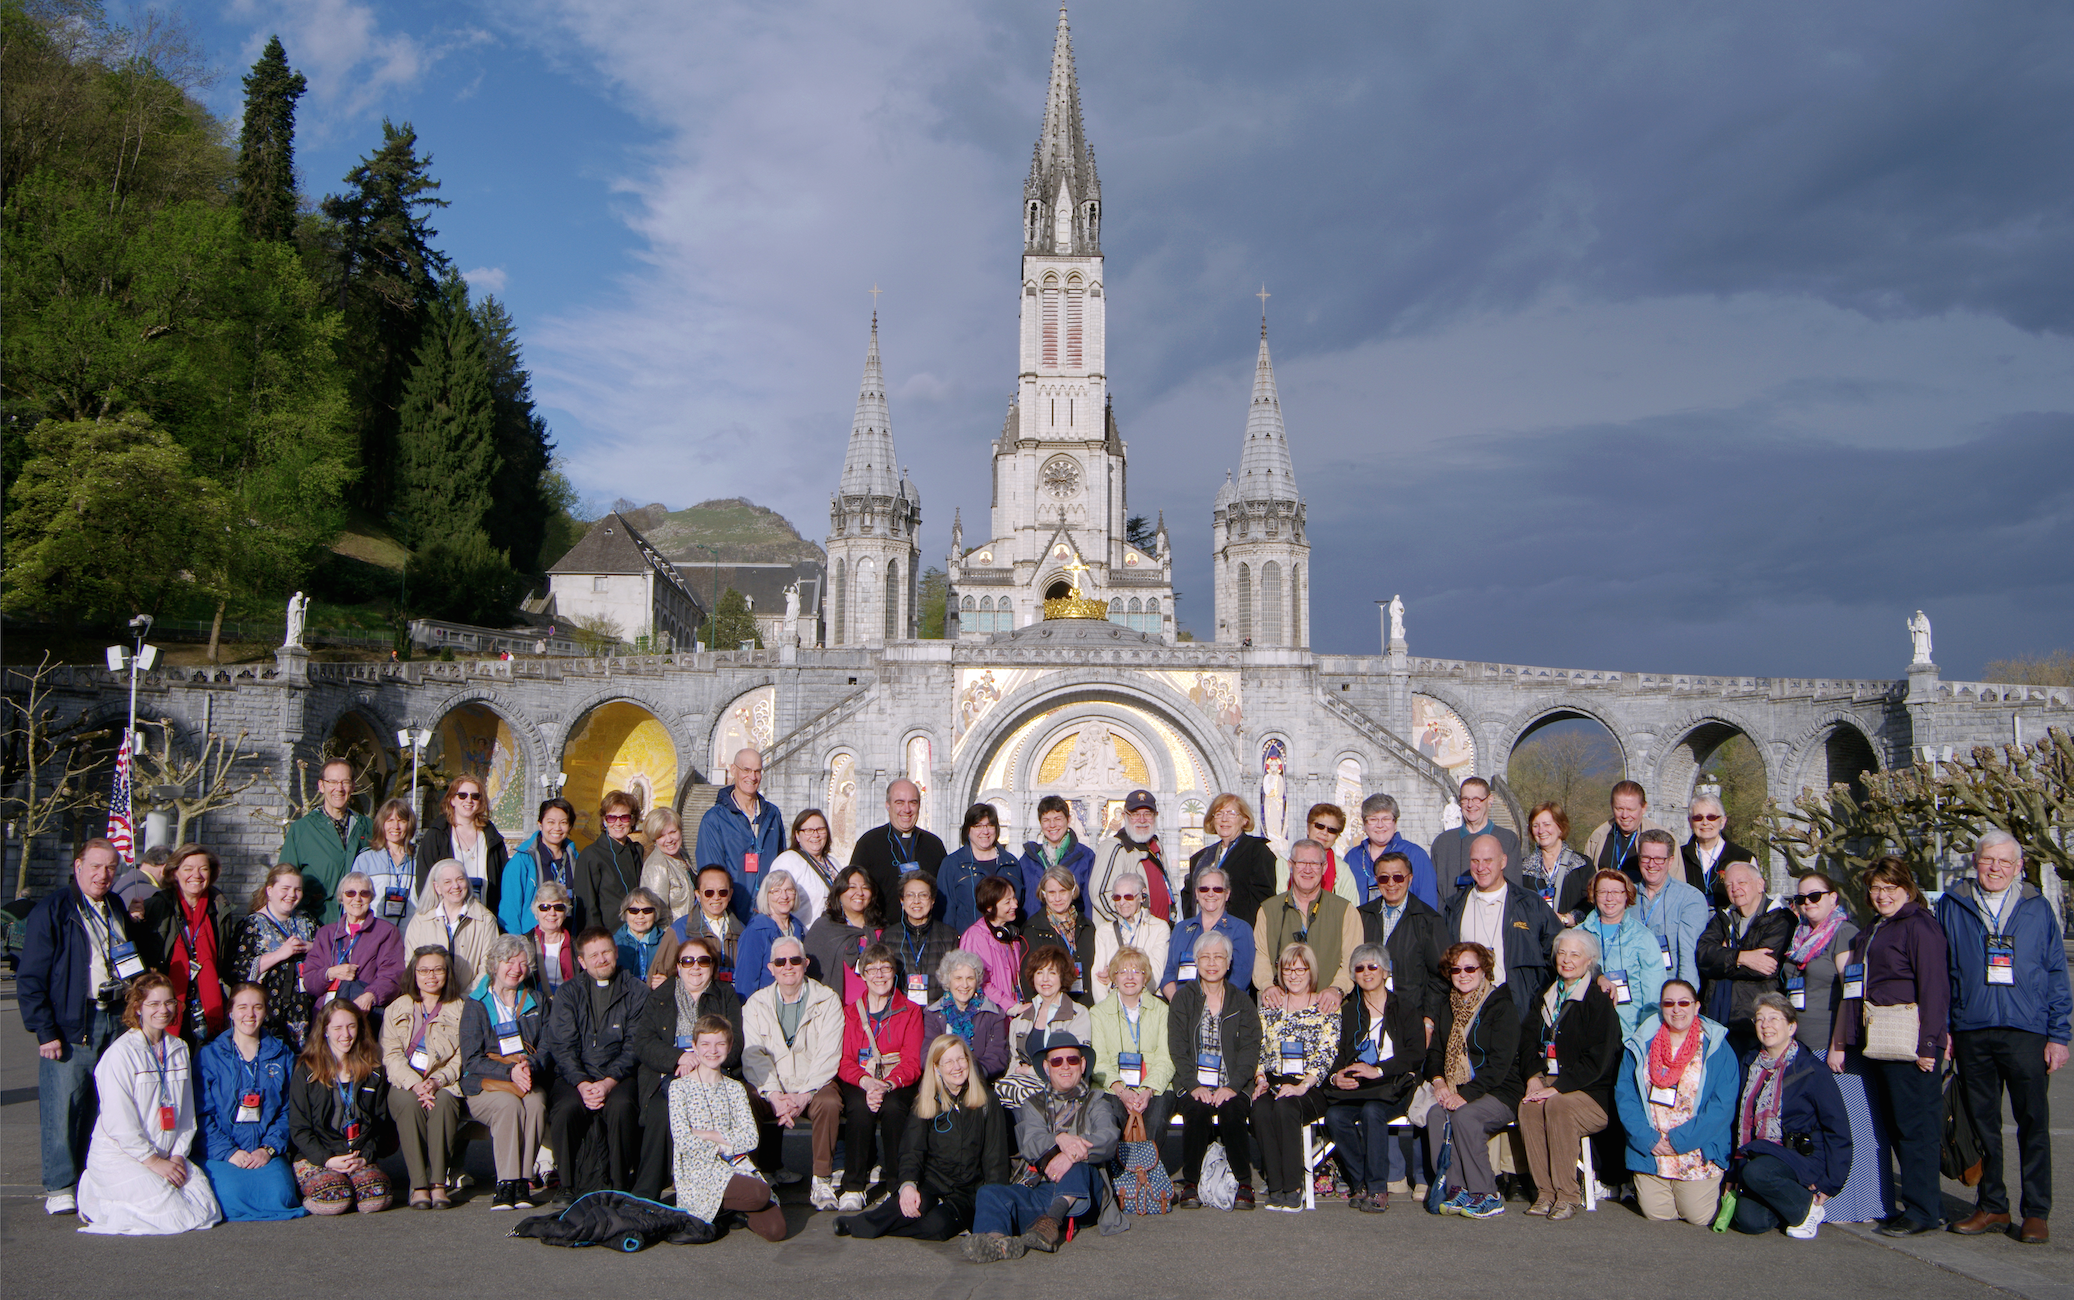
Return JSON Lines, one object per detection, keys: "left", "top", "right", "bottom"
{"left": 828, "top": 311, "right": 921, "bottom": 645}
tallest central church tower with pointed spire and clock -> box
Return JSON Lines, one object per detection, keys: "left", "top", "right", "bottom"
{"left": 946, "top": 8, "right": 1174, "bottom": 641}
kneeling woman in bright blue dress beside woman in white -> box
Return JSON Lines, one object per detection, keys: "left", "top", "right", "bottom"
{"left": 195, "top": 985, "right": 309, "bottom": 1221}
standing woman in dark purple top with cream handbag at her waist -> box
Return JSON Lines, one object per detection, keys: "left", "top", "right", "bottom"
{"left": 1829, "top": 858, "right": 1952, "bottom": 1238}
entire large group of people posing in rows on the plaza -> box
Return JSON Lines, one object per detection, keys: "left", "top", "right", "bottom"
{"left": 19, "top": 751, "right": 2074, "bottom": 1263}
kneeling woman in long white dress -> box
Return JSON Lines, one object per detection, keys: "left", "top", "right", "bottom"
{"left": 79, "top": 972, "right": 224, "bottom": 1236}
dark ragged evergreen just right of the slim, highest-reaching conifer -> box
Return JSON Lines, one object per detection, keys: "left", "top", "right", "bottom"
{"left": 324, "top": 120, "right": 450, "bottom": 510}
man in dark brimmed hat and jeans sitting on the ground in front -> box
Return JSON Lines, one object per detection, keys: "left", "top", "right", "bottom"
{"left": 964, "top": 1028, "right": 1124, "bottom": 1265}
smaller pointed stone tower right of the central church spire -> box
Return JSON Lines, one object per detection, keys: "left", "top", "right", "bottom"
{"left": 1211, "top": 315, "right": 1311, "bottom": 649}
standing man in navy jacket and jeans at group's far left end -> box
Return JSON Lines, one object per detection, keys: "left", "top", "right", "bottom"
{"left": 15, "top": 840, "right": 145, "bottom": 1215}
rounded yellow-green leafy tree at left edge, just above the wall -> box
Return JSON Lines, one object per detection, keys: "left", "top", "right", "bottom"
{"left": 0, "top": 413, "right": 232, "bottom": 620}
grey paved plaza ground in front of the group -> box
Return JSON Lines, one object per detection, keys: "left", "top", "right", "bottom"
{"left": 0, "top": 981, "right": 2074, "bottom": 1300}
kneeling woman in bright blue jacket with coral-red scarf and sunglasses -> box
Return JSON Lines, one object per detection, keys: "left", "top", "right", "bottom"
{"left": 1614, "top": 979, "right": 1742, "bottom": 1227}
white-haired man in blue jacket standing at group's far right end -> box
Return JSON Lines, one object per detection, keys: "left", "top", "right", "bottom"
{"left": 1937, "top": 831, "right": 2074, "bottom": 1246}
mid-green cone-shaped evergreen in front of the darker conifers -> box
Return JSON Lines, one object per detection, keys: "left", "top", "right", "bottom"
{"left": 392, "top": 276, "right": 498, "bottom": 549}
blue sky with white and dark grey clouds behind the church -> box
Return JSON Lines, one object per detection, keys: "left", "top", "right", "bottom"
{"left": 185, "top": 0, "right": 2074, "bottom": 678}
